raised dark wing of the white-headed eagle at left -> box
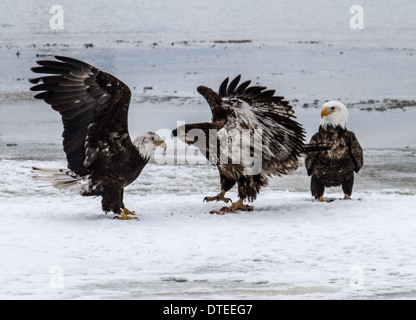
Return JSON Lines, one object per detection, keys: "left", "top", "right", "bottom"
{"left": 30, "top": 56, "right": 131, "bottom": 176}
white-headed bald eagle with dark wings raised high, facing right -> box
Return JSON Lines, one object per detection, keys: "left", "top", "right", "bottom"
{"left": 30, "top": 56, "right": 166, "bottom": 219}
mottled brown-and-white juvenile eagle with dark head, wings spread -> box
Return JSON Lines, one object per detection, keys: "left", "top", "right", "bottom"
{"left": 173, "top": 76, "right": 328, "bottom": 211}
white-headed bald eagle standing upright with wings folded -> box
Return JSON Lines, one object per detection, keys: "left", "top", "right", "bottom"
{"left": 305, "top": 101, "right": 364, "bottom": 202}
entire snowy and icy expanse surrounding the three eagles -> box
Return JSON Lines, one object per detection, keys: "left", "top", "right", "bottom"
{"left": 0, "top": 0, "right": 416, "bottom": 299}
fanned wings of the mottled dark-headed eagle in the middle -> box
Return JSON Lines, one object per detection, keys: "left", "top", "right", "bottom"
{"left": 198, "top": 76, "right": 304, "bottom": 175}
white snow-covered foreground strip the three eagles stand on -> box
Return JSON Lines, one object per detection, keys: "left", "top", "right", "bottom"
{"left": 0, "top": 150, "right": 416, "bottom": 299}
